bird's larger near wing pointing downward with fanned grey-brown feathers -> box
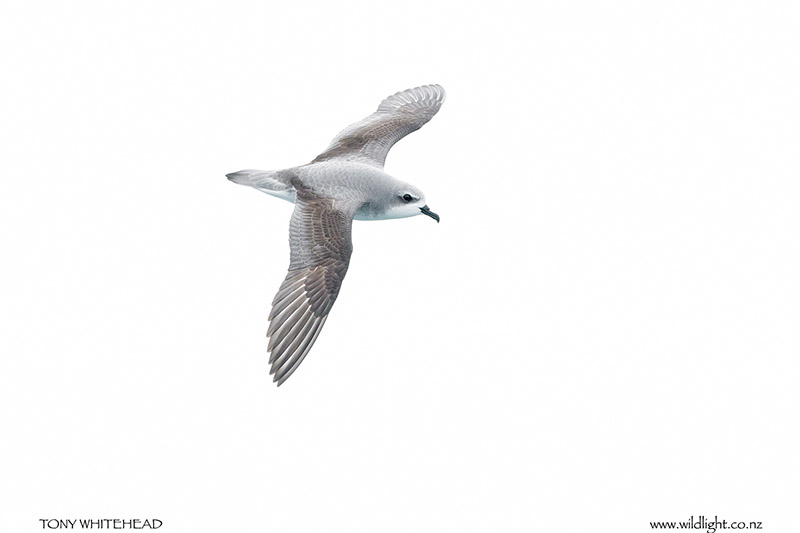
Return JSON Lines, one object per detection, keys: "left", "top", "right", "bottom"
{"left": 267, "top": 178, "right": 358, "bottom": 386}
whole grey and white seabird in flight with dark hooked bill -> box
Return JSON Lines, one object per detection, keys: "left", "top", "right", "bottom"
{"left": 227, "top": 85, "right": 445, "bottom": 386}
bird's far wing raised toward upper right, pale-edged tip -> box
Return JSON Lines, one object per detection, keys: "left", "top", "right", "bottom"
{"left": 312, "top": 85, "right": 445, "bottom": 167}
